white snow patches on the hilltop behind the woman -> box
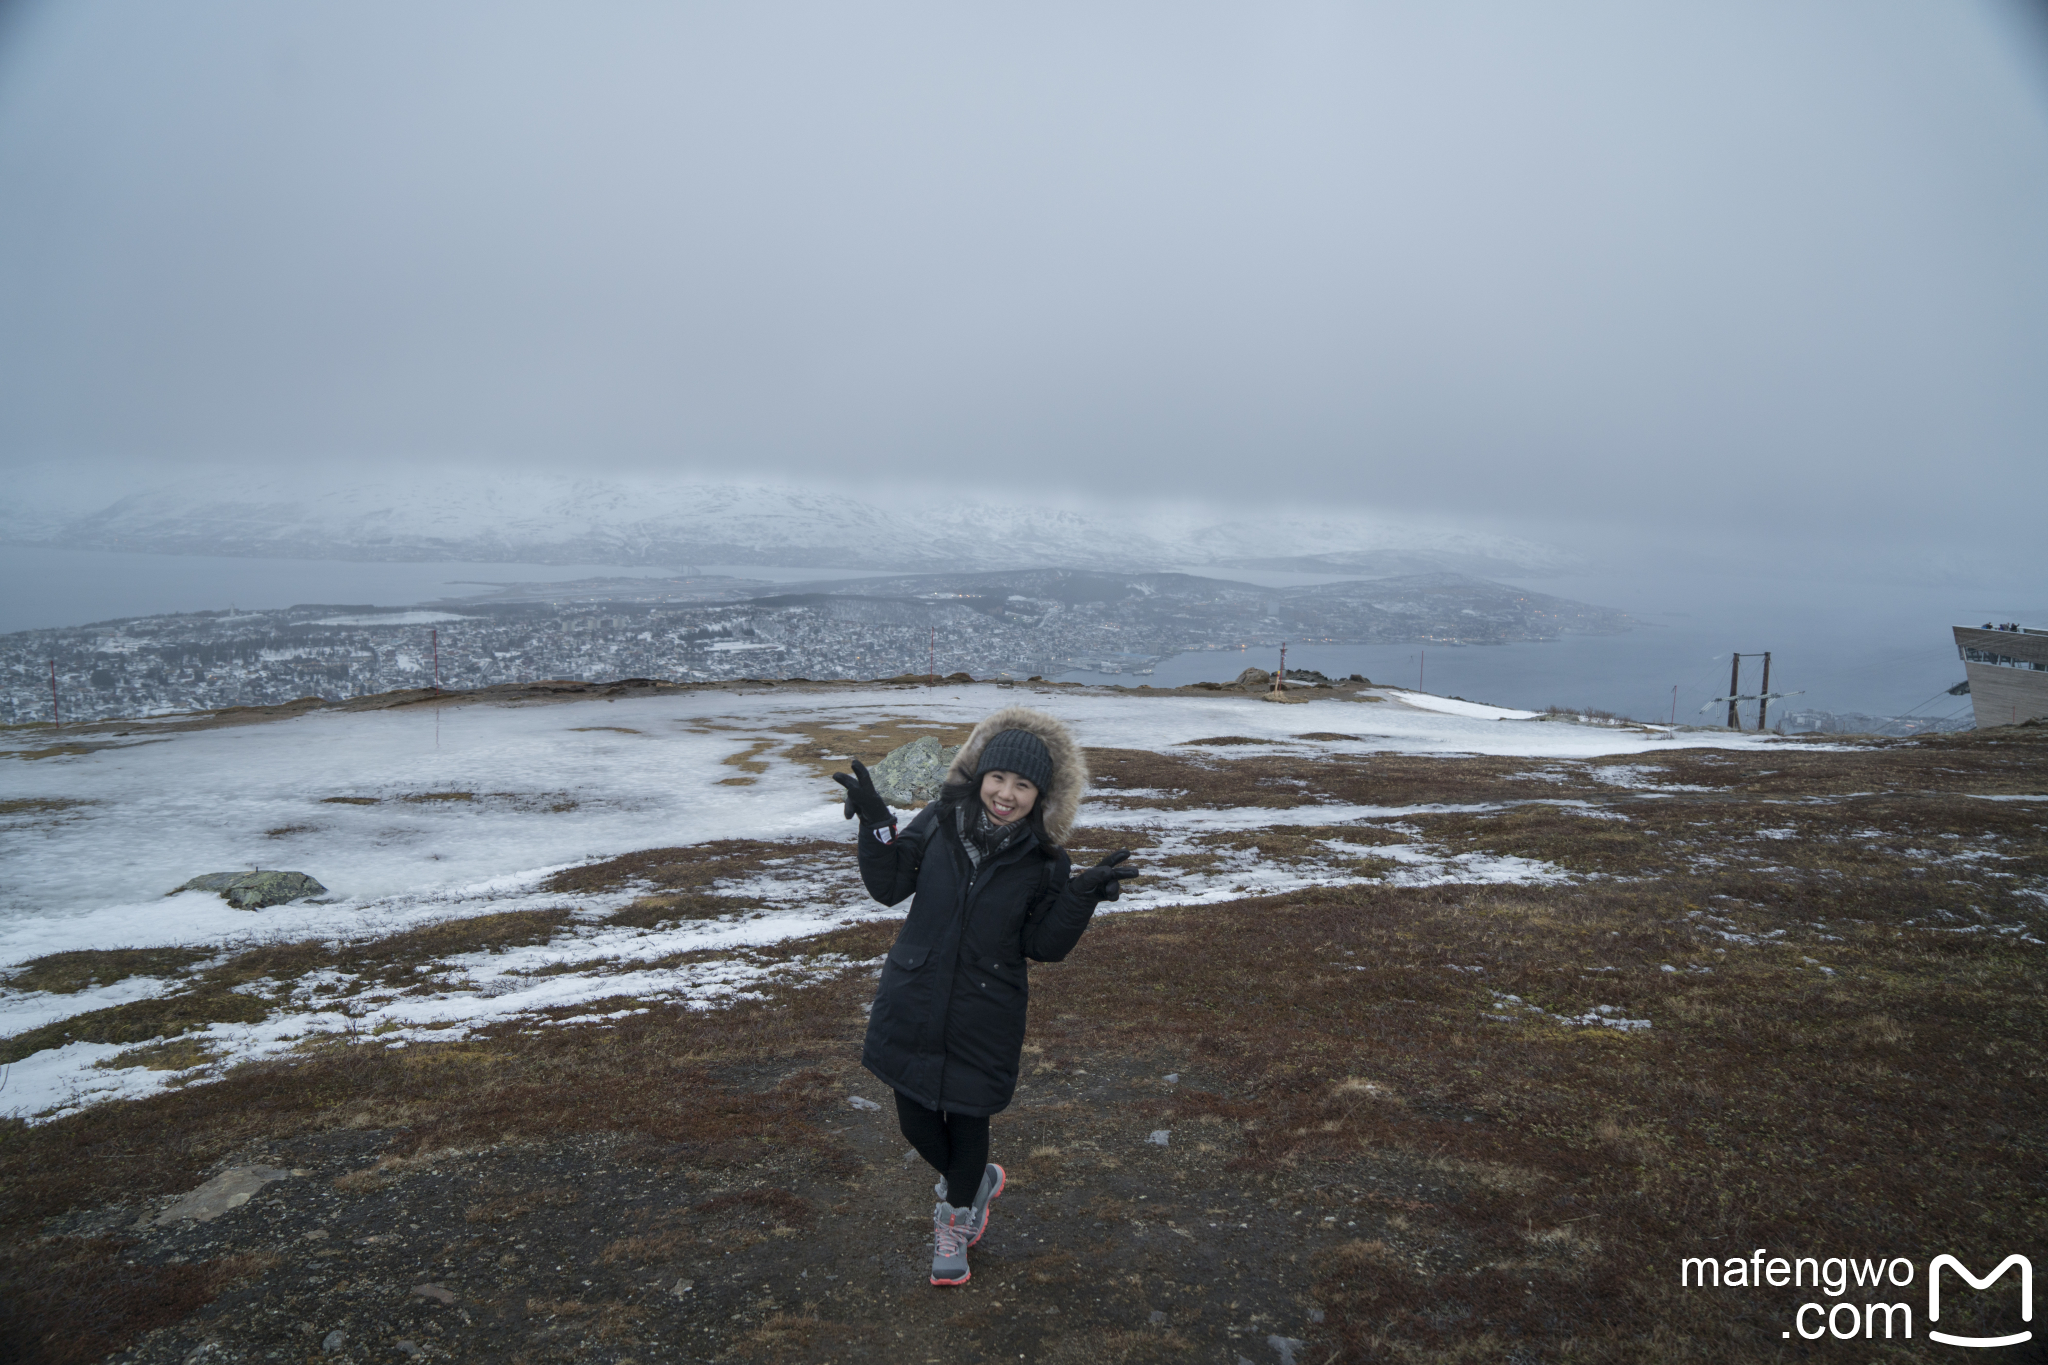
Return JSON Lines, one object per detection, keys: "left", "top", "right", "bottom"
{"left": 0, "top": 684, "right": 1810, "bottom": 1117}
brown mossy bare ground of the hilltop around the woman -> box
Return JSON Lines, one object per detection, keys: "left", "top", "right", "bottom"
{"left": 0, "top": 722, "right": 2048, "bottom": 1365}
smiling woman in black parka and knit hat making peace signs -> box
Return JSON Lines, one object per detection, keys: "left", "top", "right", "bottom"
{"left": 834, "top": 706, "right": 1137, "bottom": 1285}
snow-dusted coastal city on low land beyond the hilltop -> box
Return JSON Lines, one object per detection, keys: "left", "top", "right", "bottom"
{"left": 0, "top": 569, "right": 1628, "bottom": 724}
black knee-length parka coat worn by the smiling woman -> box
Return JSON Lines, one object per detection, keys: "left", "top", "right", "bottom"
{"left": 860, "top": 796, "right": 1096, "bottom": 1113}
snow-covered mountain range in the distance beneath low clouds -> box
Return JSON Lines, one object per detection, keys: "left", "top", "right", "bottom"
{"left": 0, "top": 473, "right": 1573, "bottom": 573}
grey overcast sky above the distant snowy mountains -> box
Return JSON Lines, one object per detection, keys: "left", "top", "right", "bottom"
{"left": 0, "top": 0, "right": 2048, "bottom": 565}
